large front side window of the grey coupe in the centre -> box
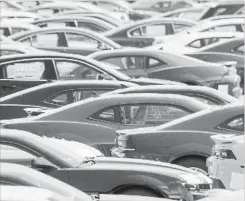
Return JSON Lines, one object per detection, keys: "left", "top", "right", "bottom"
{"left": 123, "top": 104, "right": 190, "bottom": 124}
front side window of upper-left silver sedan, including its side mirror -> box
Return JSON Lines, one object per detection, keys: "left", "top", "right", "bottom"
{"left": 64, "top": 32, "right": 112, "bottom": 56}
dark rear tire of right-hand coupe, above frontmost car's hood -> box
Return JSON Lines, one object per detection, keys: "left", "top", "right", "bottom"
{"left": 174, "top": 157, "right": 208, "bottom": 172}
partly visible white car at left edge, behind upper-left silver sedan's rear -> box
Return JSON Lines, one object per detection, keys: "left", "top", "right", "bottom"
{"left": 0, "top": 19, "right": 38, "bottom": 37}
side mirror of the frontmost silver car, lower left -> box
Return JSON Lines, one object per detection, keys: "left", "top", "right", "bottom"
{"left": 31, "top": 157, "right": 57, "bottom": 173}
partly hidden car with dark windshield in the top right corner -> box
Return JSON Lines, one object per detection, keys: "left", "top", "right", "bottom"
{"left": 157, "top": 0, "right": 244, "bottom": 21}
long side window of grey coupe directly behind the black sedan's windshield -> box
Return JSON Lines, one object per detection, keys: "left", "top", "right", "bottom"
{"left": 98, "top": 55, "right": 147, "bottom": 78}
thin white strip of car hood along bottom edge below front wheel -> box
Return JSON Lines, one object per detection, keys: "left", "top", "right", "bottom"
{"left": 99, "top": 194, "right": 171, "bottom": 201}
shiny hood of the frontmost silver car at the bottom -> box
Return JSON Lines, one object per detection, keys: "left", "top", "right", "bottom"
{"left": 90, "top": 157, "right": 212, "bottom": 184}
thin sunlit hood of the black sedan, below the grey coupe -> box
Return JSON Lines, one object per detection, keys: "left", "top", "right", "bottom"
{"left": 129, "top": 78, "right": 186, "bottom": 85}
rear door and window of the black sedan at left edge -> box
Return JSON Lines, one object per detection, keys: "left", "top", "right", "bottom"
{"left": 0, "top": 59, "right": 57, "bottom": 97}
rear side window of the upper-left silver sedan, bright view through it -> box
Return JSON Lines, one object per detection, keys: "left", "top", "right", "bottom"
{"left": 20, "top": 32, "right": 67, "bottom": 52}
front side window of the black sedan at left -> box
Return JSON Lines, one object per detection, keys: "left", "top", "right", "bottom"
{"left": 56, "top": 60, "right": 101, "bottom": 80}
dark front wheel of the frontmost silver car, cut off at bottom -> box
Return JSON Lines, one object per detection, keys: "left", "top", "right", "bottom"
{"left": 116, "top": 188, "right": 160, "bottom": 197}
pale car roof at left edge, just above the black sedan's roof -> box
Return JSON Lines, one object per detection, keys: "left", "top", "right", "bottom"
{"left": 0, "top": 42, "right": 41, "bottom": 56}
